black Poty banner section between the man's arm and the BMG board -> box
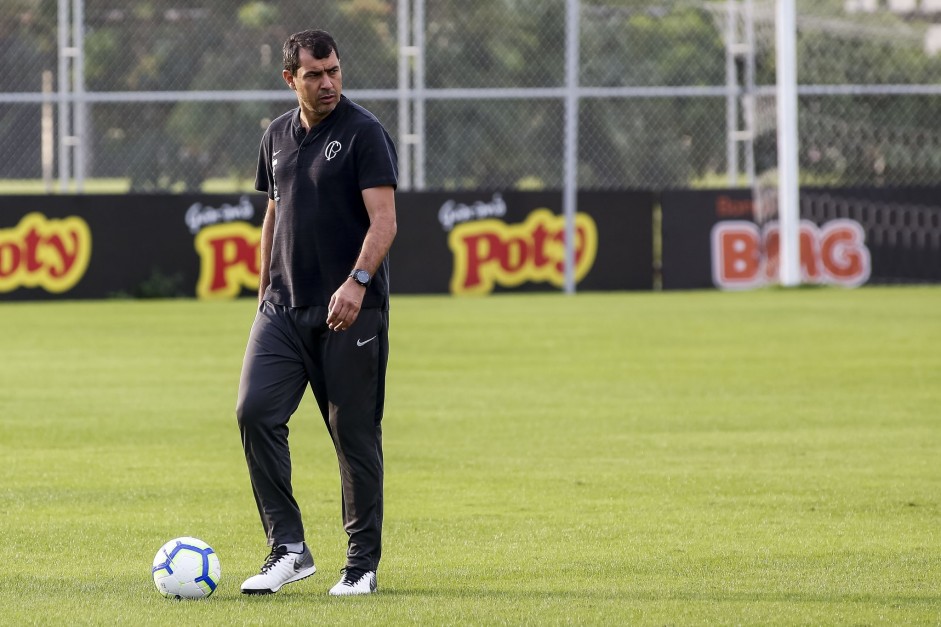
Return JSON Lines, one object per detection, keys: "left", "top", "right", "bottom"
{"left": 390, "top": 192, "right": 654, "bottom": 294}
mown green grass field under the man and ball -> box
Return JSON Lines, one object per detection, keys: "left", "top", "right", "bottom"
{"left": 0, "top": 287, "right": 941, "bottom": 625}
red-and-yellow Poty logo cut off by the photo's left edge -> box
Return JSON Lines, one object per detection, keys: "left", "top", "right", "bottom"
{"left": 0, "top": 213, "right": 91, "bottom": 294}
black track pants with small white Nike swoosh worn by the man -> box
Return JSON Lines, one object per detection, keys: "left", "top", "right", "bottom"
{"left": 236, "top": 302, "right": 389, "bottom": 570}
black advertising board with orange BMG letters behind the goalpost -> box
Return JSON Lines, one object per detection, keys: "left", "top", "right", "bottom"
{"left": 661, "top": 188, "right": 941, "bottom": 289}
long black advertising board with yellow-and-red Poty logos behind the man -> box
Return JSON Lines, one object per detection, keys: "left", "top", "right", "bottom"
{"left": 0, "top": 192, "right": 653, "bottom": 300}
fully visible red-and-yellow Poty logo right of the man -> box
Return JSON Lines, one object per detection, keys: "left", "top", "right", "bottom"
{"left": 448, "top": 209, "right": 598, "bottom": 294}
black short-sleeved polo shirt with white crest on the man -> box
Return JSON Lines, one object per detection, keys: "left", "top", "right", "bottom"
{"left": 255, "top": 96, "right": 398, "bottom": 309}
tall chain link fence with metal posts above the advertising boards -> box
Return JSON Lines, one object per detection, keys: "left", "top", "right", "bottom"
{"left": 0, "top": 0, "right": 941, "bottom": 193}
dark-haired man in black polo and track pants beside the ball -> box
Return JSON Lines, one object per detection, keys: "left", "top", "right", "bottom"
{"left": 236, "top": 30, "right": 397, "bottom": 595}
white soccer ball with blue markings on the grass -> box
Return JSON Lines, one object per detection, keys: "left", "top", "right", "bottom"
{"left": 152, "top": 537, "right": 222, "bottom": 599}
